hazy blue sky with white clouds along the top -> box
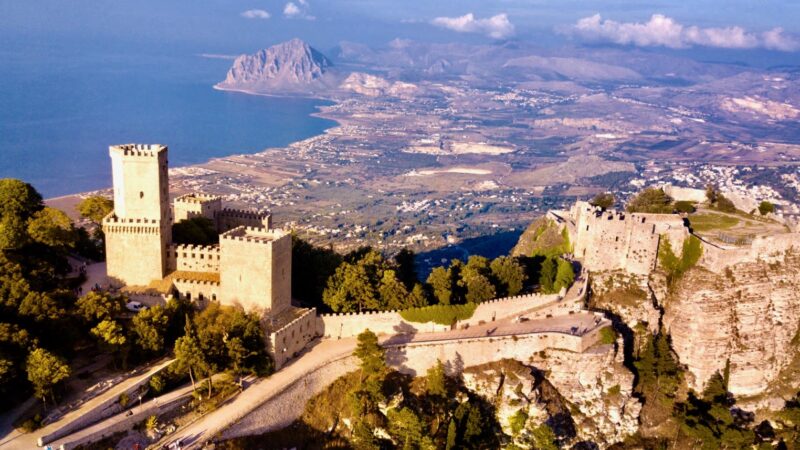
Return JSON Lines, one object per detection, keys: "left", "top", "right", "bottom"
{"left": 0, "top": 0, "right": 800, "bottom": 54}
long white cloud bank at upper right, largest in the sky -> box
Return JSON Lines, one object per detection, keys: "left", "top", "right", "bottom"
{"left": 567, "top": 14, "right": 800, "bottom": 51}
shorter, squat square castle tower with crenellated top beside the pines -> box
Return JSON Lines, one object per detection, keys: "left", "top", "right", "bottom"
{"left": 219, "top": 226, "right": 292, "bottom": 316}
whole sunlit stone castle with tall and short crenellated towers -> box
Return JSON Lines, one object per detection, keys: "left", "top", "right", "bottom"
{"left": 103, "top": 144, "right": 316, "bottom": 367}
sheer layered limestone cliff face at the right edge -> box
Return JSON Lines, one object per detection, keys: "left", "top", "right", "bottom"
{"left": 664, "top": 252, "right": 800, "bottom": 397}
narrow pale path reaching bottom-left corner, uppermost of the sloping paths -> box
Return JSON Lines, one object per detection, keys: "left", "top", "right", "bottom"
{"left": 0, "top": 359, "right": 174, "bottom": 450}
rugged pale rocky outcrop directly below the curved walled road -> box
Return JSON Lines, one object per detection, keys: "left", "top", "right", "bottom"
{"left": 463, "top": 345, "right": 641, "bottom": 448}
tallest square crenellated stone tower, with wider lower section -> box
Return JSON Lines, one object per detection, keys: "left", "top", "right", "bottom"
{"left": 103, "top": 144, "right": 172, "bottom": 286}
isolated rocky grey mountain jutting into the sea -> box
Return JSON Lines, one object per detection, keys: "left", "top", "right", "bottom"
{"left": 215, "top": 39, "right": 341, "bottom": 95}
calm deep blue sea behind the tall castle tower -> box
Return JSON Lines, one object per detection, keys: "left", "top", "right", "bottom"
{"left": 0, "top": 45, "right": 335, "bottom": 198}
